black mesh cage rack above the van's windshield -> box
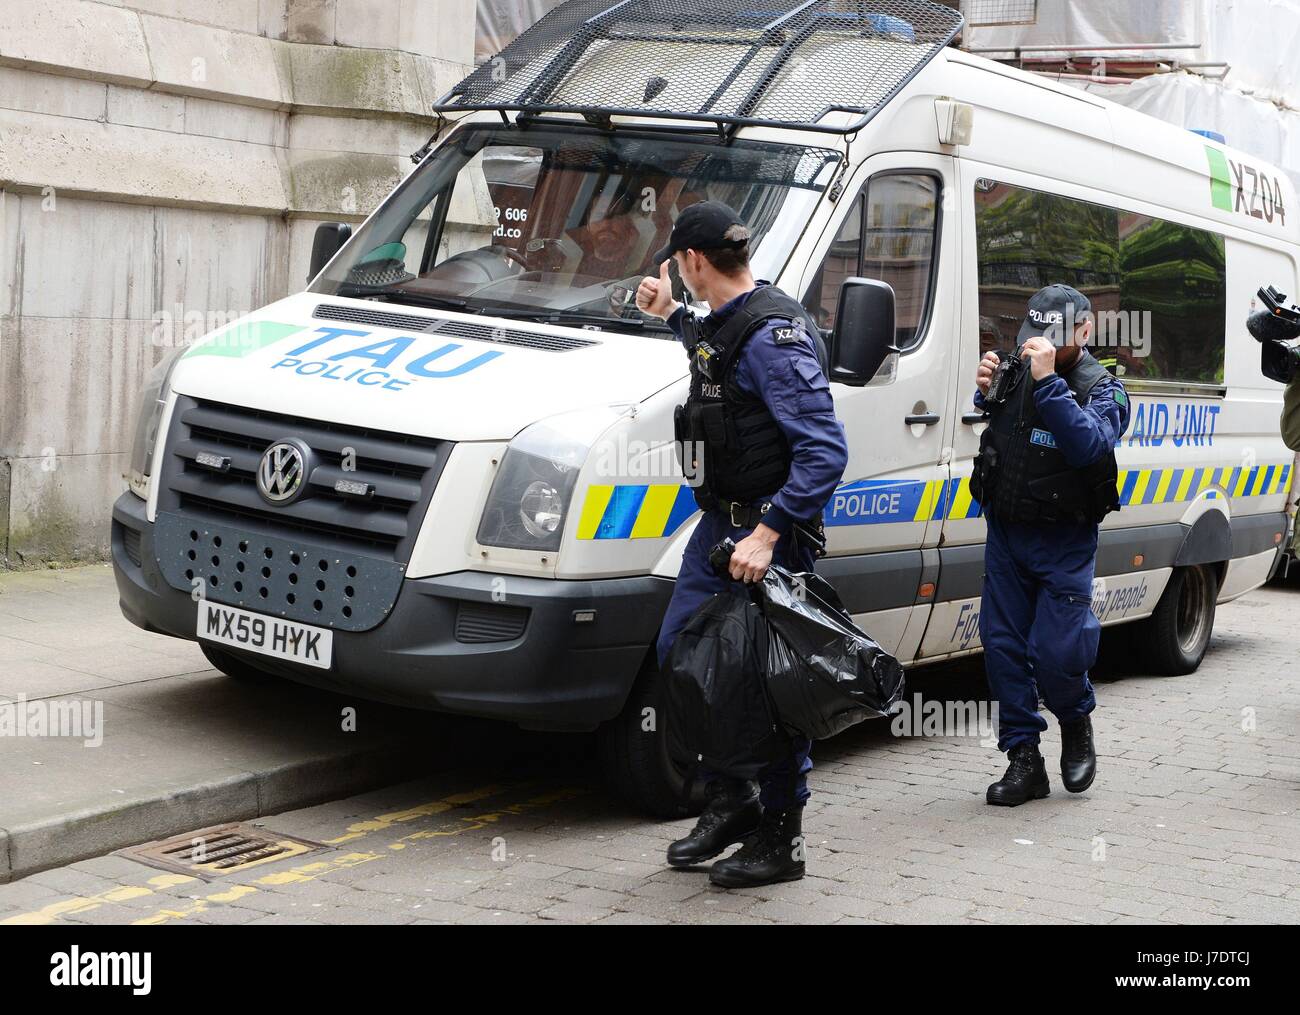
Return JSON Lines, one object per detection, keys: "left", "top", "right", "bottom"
{"left": 434, "top": 0, "right": 962, "bottom": 134}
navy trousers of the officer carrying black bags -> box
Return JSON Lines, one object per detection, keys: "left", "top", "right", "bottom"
{"left": 655, "top": 511, "right": 815, "bottom": 811}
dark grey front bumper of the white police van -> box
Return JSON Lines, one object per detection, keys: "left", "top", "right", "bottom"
{"left": 112, "top": 494, "right": 673, "bottom": 730}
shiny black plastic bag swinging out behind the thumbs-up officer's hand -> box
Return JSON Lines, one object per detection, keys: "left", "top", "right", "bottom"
{"left": 758, "top": 564, "right": 905, "bottom": 739}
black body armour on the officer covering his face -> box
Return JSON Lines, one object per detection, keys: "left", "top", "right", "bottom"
{"left": 971, "top": 351, "right": 1119, "bottom": 525}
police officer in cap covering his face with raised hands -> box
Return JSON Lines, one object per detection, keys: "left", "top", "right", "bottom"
{"left": 971, "top": 285, "right": 1128, "bottom": 807}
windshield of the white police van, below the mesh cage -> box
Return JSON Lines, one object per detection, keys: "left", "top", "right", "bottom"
{"left": 311, "top": 123, "right": 840, "bottom": 329}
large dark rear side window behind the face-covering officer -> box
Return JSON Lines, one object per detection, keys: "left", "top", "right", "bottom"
{"left": 975, "top": 179, "right": 1227, "bottom": 385}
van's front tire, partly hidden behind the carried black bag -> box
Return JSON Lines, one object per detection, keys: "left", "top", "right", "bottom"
{"left": 597, "top": 652, "right": 705, "bottom": 820}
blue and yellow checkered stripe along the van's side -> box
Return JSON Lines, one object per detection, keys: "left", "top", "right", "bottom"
{"left": 577, "top": 463, "right": 1291, "bottom": 539}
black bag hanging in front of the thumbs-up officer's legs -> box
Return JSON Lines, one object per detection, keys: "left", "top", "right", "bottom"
{"left": 663, "top": 586, "right": 793, "bottom": 778}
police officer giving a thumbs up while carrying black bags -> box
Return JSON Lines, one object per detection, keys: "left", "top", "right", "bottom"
{"left": 637, "top": 201, "right": 848, "bottom": 888}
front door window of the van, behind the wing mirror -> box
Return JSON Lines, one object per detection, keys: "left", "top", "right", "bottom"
{"left": 803, "top": 172, "right": 940, "bottom": 350}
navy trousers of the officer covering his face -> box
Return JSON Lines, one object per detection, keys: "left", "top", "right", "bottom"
{"left": 979, "top": 519, "right": 1101, "bottom": 751}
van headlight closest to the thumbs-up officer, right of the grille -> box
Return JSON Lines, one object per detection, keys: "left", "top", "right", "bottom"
{"left": 478, "top": 407, "right": 625, "bottom": 550}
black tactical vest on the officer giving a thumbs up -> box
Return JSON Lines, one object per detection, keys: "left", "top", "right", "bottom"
{"left": 675, "top": 286, "right": 827, "bottom": 511}
